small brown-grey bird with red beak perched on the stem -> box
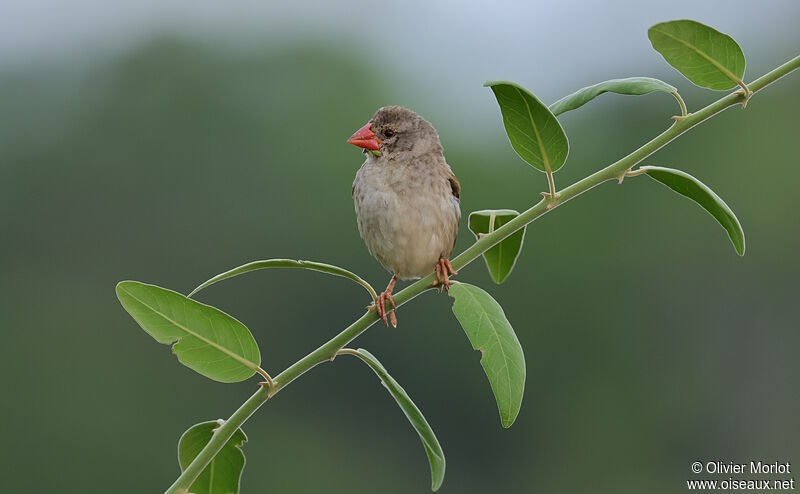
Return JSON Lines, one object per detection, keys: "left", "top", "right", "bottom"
{"left": 347, "top": 106, "right": 461, "bottom": 327}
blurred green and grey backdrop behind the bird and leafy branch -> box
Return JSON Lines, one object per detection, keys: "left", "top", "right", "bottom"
{"left": 0, "top": 1, "right": 800, "bottom": 493}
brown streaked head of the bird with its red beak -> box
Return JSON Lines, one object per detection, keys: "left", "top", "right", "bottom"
{"left": 347, "top": 106, "right": 442, "bottom": 160}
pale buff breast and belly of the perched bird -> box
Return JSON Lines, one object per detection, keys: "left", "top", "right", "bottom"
{"left": 353, "top": 177, "right": 461, "bottom": 279}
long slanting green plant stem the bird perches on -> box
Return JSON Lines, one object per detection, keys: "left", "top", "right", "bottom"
{"left": 166, "top": 55, "right": 800, "bottom": 494}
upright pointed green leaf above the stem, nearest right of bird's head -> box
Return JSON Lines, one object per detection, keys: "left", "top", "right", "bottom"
{"left": 484, "top": 81, "right": 569, "bottom": 172}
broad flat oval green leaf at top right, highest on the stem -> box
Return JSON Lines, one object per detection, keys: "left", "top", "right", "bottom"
{"left": 647, "top": 20, "right": 745, "bottom": 90}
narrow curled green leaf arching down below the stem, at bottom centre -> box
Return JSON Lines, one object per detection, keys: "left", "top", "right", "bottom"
{"left": 340, "top": 348, "right": 445, "bottom": 491}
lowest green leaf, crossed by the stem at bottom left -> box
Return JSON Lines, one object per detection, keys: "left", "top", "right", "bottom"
{"left": 178, "top": 419, "right": 247, "bottom": 494}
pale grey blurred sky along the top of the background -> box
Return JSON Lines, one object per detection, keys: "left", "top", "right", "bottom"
{"left": 6, "top": 0, "right": 800, "bottom": 125}
